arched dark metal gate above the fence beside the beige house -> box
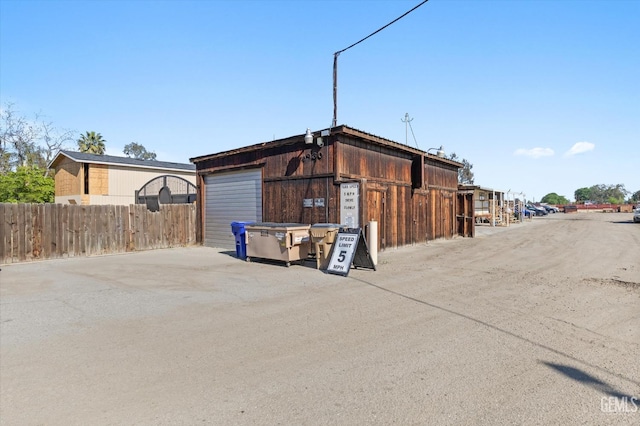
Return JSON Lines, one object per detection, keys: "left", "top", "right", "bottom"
{"left": 136, "top": 175, "right": 197, "bottom": 212}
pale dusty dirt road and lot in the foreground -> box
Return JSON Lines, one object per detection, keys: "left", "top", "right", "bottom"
{"left": 0, "top": 213, "right": 640, "bottom": 425}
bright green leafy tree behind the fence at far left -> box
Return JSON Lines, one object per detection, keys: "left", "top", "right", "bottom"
{"left": 0, "top": 166, "right": 55, "bottom": 203}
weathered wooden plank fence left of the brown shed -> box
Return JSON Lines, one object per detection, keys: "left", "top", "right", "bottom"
{"left": 0, "top": 203, "right": 196, "bottom": 264}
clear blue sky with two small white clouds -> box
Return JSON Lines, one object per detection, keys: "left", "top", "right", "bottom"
{"left": 0, "top": 0, "right": 640, "bottom": 200}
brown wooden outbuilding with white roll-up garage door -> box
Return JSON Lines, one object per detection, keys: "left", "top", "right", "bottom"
{"left": 190, "top": 125, "right": 473, "bottom": 250}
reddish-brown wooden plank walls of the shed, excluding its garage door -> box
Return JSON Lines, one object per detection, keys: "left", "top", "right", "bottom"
{"left": 195, "top": 129, "right": 464, "bottom": 250}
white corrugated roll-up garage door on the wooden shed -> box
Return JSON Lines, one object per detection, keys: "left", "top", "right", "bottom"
{"left": 204, "top": 169, "right": 262, "bottom": 249}
